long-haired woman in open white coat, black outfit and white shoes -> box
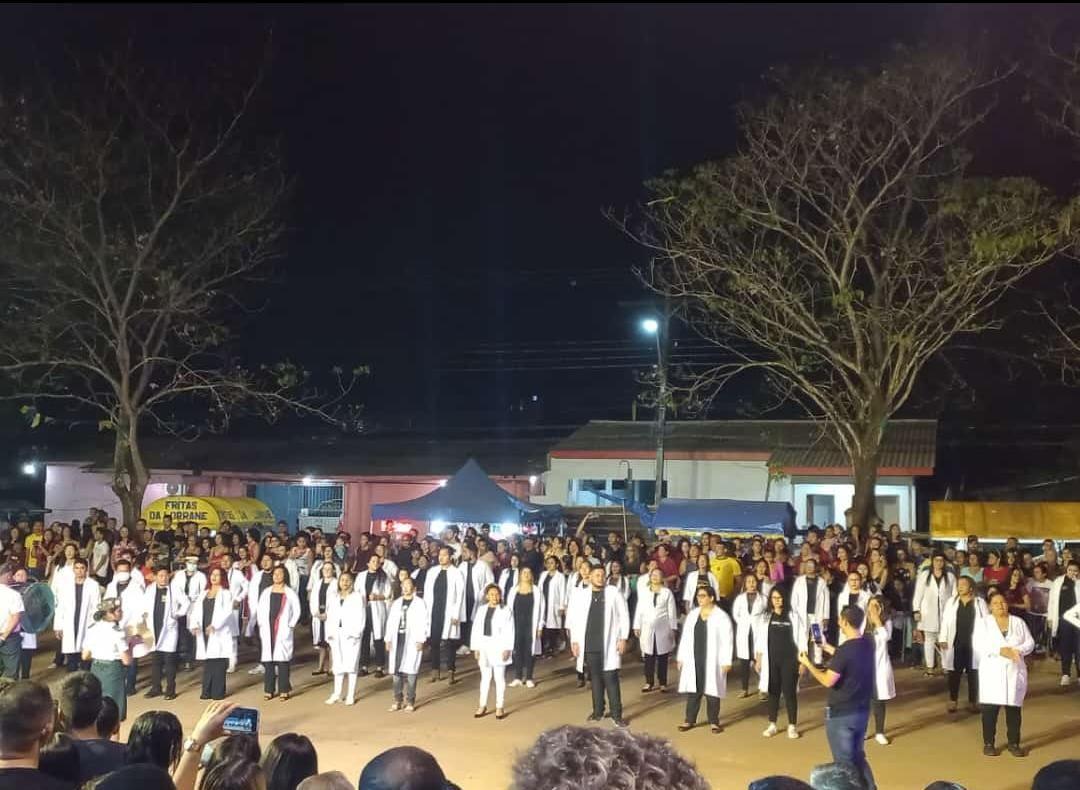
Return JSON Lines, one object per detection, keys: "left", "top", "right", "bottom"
{"left": 754, "top": 586, "right": 810, "bottom": 739}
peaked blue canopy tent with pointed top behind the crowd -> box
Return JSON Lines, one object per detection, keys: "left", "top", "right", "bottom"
{"left": 372, "top": 458, "right": 563, "bottom": 524}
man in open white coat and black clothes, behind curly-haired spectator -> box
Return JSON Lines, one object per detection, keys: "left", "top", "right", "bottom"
{"left": 568, "top": 564, "right": 630, "bottom": 728}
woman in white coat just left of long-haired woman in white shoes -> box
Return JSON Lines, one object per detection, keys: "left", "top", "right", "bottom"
{"left": 673, "top": 587, "right": 734, "bottom": 735}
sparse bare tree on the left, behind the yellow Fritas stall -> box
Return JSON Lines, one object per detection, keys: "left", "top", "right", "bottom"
{"left": 0, "top": 57, "right": 362, "bottom": 523}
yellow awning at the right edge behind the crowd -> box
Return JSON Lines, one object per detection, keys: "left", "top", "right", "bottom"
{"left": 930, "top": 501, "right": 1080, "bottom": 540}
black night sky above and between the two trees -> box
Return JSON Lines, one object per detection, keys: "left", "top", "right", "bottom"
{"left": 0, "top": 4, "right": 1071, "bottom": 436}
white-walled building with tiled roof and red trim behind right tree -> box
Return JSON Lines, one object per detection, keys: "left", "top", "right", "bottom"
{"left": 532, "top": 419, "right": 937, "bottom": 531}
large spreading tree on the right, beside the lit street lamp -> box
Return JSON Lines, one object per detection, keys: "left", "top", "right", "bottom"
{"left": 619, "top": 52, "right": 1071, "bottom": 524}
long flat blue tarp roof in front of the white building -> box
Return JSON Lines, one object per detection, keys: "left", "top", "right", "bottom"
{"left": 652, "top": 499, "right": 795, "bottom": 535}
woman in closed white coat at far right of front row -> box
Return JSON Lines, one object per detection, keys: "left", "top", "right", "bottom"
{"left": 974, "top": 592, "right": 1035, "bottom": 758}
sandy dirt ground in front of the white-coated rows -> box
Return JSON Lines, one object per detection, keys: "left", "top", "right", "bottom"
{"left": 35, "top": 631, "right": 1080, "bottom": 790}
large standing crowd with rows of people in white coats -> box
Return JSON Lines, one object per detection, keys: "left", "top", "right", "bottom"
{"left": 0, "top": 510, "right": 1080, "bottom": 787}
